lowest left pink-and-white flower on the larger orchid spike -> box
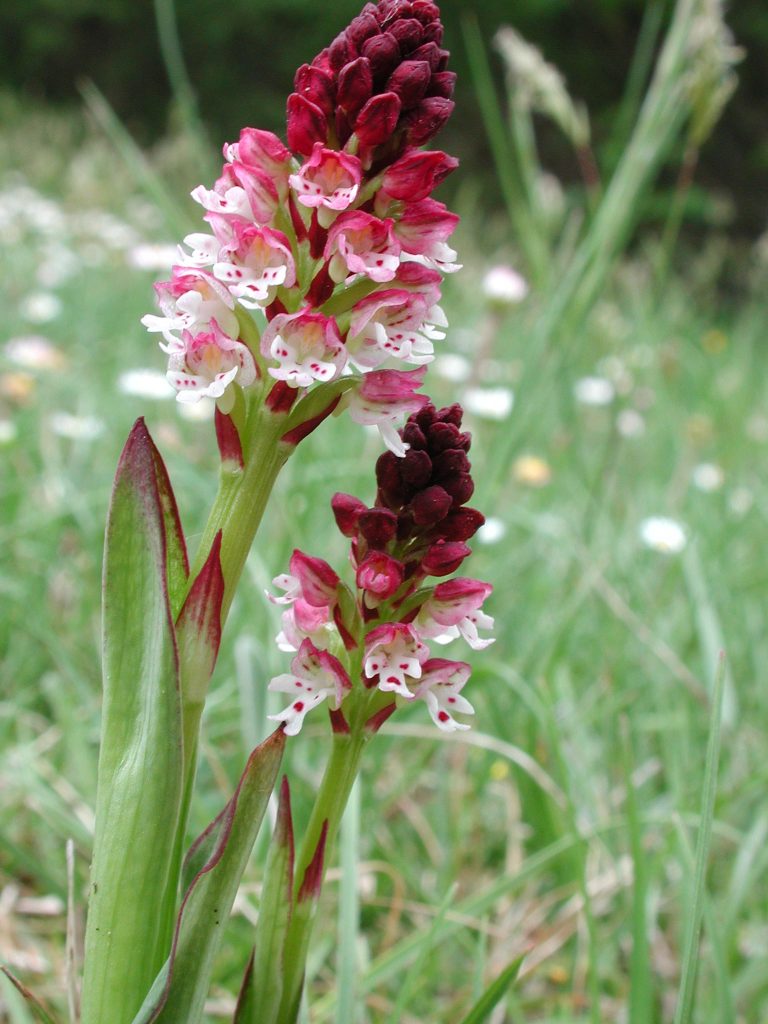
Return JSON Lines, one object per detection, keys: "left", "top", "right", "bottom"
{"left": 163, "top": 319, "right": 256, "bottom": 412}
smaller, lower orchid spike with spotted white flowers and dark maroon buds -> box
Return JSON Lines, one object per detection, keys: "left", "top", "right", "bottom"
{"left": 269, "top": 406, "right": 494, "bottom": 735}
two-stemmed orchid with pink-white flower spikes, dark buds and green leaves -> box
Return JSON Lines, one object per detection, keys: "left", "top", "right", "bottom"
{"left": 7, "top": 0, "right": 493, "bottom": 1024}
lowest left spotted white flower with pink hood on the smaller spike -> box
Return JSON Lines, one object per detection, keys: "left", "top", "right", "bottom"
{"left": 268, "top": 639, "right": 351, "bottom": 736}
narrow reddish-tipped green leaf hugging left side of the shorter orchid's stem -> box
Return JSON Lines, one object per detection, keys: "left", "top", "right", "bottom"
{"left": 233, "top": 776, "right": 294, "bottom": 1024}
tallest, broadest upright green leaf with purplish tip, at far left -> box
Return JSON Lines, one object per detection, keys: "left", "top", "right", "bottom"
{"left": 82, "top": 420, "right": 183, "bottom": 1024}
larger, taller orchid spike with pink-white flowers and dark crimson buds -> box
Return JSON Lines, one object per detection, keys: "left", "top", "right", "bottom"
{"left": 142, "top": 0, "right": 459, "bottom": 455}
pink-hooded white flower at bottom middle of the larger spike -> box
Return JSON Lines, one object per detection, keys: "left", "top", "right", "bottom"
{"left": 261, "top": 310, "right": 347, "bottom": 387}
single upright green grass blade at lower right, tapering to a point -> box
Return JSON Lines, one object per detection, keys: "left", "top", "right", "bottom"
{"left": 674, "top": 654, "right": 725, "bottom": 1024}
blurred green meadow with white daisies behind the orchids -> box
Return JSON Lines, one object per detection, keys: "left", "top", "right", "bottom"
{"left": 0, "top": 0, "right": 768, "bottom": 1024}
